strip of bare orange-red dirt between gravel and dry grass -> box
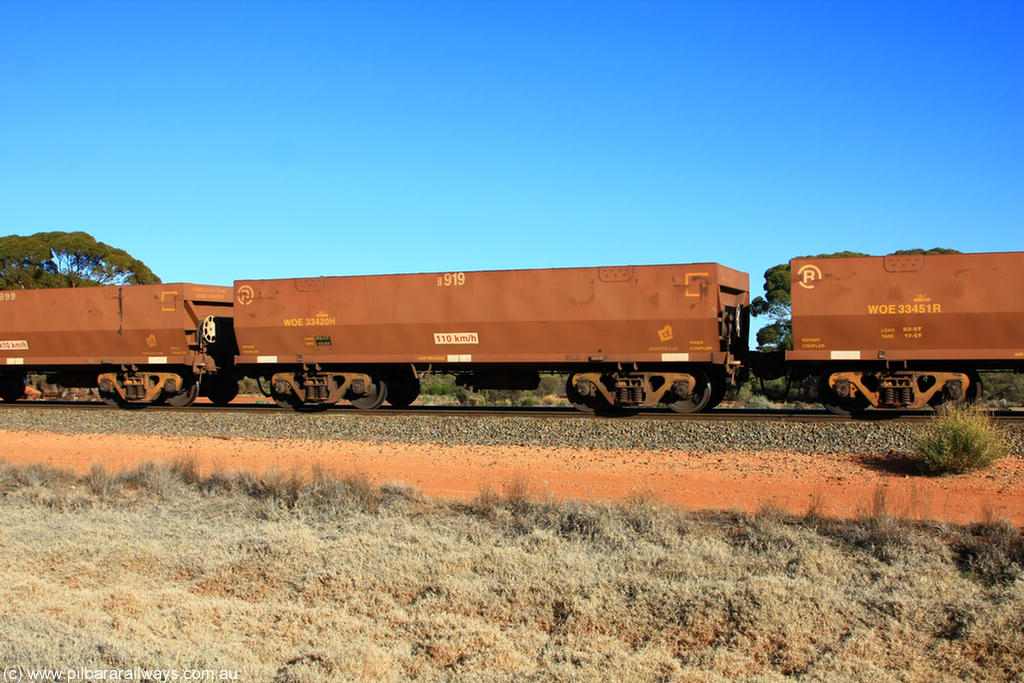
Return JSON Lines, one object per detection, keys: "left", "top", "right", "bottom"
{"left": 0, "top": 430, "right": 1024, "bottom": 526}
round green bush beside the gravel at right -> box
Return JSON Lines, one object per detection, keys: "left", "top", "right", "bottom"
{"left": 913, "top": 407, "right": 1009, "bottom": 475}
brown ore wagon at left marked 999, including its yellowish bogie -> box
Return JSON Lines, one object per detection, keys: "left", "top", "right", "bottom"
{"left": 0, "top": 283, "right": 238, "bottom": 408}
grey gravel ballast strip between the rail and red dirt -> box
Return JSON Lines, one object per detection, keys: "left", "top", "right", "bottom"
{"left": 0, "top": 407, "right": 1024, "bottom": 456}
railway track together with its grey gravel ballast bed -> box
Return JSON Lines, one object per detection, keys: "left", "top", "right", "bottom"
{"left": 0, "top": 401, "right": 1024, "bottom": 458}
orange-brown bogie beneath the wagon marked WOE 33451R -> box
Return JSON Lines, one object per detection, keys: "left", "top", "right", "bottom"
{"left": 827, "top": 371, "right": 978, "bottom": 410}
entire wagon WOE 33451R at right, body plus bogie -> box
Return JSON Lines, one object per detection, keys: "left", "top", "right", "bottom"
{"left": 786, "top": 252, "right": 1024, "bottom": 413}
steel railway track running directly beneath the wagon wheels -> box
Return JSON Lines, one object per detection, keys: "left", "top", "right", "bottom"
{"left": 0, "top": 400, "right": 1024, "bottom": 423}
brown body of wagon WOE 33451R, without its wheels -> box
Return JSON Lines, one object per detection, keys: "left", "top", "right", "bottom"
{"left": 787, "top": 252, "right": 1024, "bottom": 367}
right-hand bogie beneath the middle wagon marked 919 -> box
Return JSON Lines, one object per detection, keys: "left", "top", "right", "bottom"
{"left": 569, "top": 372, "right": 700, "bottom": 408}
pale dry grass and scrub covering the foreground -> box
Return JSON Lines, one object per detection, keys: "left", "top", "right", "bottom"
{"left": 0, "top": 462, "right": 1024, "bottom": 683}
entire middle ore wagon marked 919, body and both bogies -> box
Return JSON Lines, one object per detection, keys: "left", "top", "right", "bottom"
{"left": 234, "top": 263, "right": 750, "bottom": 412}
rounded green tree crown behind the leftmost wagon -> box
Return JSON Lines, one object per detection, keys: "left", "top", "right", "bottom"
{"left": 0, "top": 231, "right": 160, "bottom": 290}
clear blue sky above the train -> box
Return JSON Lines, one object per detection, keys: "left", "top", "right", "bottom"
{"left": 0, "top": 0, "right": 1024, "bottom": 293}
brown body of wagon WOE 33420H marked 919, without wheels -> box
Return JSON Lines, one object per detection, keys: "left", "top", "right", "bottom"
{"left": 234, "top": 263, "right": 750, "bottom": 369}
